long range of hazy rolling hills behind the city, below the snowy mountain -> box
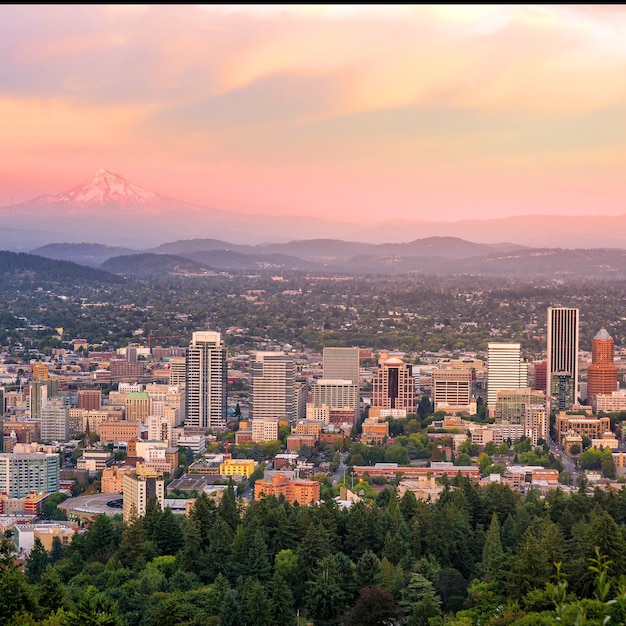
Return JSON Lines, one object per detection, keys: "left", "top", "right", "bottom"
{"left": 24, "top": 237, "right": 626, "bottom": 279}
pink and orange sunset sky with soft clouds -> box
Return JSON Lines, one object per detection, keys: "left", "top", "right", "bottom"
{"left": 0, "top": 5, "right": 626, "bottom": 222}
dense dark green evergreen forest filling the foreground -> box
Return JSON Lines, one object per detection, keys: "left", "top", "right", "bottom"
{"left": 6, "top": 477, "right": 626, "bottom": 626}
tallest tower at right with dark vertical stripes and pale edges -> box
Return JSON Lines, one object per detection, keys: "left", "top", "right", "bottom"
{"left": 546, "top": 307, "right": 580, "bottom": 413}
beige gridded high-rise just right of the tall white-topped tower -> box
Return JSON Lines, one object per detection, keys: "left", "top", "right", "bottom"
{"left": 250, "top": 352, "right": 296, "bottom": 424}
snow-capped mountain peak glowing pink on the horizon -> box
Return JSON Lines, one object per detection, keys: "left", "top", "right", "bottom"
{"left": 13, "top": 169, "right": 190, "bottom": 215}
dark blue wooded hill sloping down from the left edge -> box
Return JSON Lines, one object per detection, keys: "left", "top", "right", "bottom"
{"left": 0, "top": 250, "right": 122, "bottom": 283}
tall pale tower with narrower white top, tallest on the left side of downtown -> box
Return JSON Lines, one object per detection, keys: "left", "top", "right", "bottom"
{"left": 185, "top": 331, "right": 228, "bottom": 429}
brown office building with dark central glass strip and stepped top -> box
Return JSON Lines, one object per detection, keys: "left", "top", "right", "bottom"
{"left": 372, "top": 350, "right": 415, "bottom": 413}
